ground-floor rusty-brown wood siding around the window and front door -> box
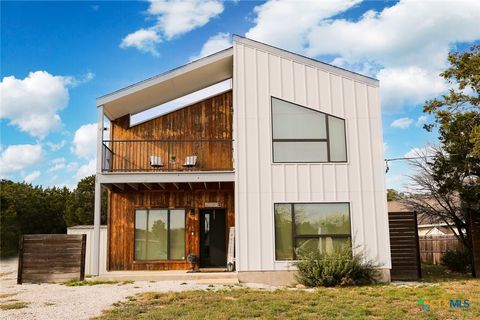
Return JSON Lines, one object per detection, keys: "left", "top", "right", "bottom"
{"left": 108, "top": 182, "right": 235, "bottom": 271}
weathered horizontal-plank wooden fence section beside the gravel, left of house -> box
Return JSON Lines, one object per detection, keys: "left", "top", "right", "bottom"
{"left": 17, "top": 234, "right": 86, "bottom": 284}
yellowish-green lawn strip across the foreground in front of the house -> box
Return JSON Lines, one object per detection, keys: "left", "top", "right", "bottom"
{"left": 95, "top": 279, "right": 480, "bottom": 320}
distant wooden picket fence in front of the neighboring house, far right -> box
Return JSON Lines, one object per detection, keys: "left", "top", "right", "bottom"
{"left": 419, "top": 235, "right": 463, "bottom": 264}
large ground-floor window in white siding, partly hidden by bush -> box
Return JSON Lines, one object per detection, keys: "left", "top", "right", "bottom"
{"left": 275, "top": 203, "right": 351, "bottom": 260}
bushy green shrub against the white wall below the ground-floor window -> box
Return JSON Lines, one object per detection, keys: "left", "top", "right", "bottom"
{"left": 294, "top": 246, "right": 380, "bottom": 287}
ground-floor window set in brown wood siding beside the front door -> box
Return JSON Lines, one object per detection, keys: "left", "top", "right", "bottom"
{"left": 135, "top": 209, "right": 185, "bottom": 260}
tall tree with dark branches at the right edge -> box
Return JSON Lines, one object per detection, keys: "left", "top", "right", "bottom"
{"left": 405, "top": 46, "right": 480, "bottom": 255}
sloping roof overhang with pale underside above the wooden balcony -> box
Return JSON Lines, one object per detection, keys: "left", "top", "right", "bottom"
{"left": 97, "top": 48, "right": 233, "bottom": 120}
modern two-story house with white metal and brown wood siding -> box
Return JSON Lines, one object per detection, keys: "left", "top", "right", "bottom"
{"left": 93, "top": 36, "right": 391, "bottom": 283}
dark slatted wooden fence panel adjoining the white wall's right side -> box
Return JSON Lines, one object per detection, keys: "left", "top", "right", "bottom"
{"left": 388, "top": 212, "right": 422, "bottom": 280}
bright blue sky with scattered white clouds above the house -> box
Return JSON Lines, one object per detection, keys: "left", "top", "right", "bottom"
{"left": 0, "top": 0, "right": 480, "bottom": 188}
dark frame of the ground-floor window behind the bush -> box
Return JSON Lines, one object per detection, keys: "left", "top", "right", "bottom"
{"left": 273, "top": 201, "right": 353, "bottom": 262}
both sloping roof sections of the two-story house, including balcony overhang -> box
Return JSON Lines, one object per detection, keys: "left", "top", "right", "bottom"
{"left": 96, "top": 35, "right": 379, "bottom": 120}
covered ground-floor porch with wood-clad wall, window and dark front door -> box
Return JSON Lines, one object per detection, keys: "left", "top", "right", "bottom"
{"left": 102, "top": 181, "right": 235, "bottom": 272}
